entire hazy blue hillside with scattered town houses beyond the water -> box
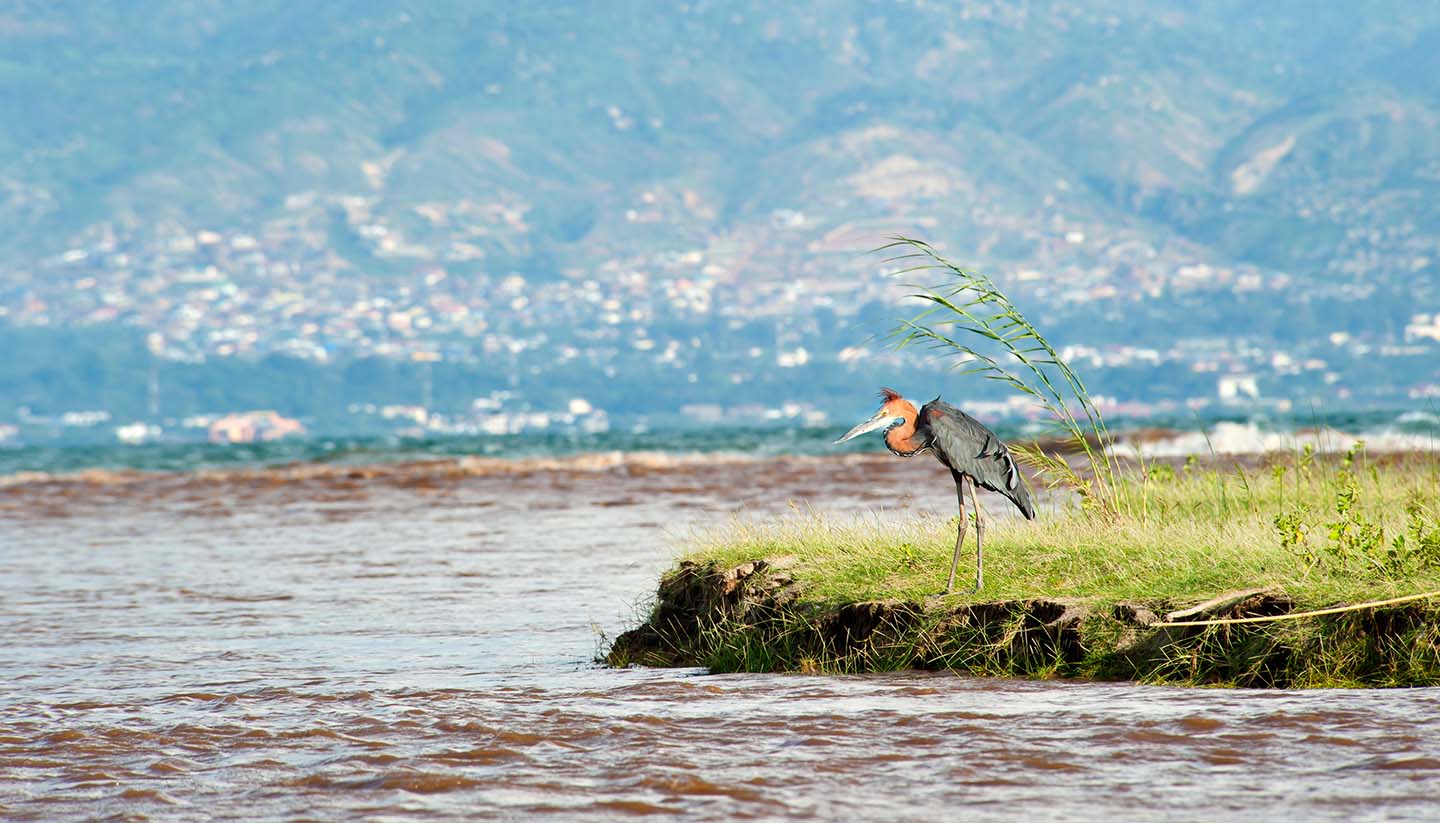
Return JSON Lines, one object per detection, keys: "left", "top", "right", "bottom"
{"left": 0, "top": 0, "right": 1440, "bottom": 436}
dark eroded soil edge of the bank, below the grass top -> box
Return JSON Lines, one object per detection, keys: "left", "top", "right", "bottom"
{"left": 606, "top": 558, "right": 1440, "bottom": 688}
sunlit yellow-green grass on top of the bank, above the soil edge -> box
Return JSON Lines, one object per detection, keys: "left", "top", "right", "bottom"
{"left": 684, "top": 450, "right": 1440, "bottom": 606}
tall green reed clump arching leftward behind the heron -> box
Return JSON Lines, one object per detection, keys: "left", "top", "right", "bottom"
{"left": 877, "top": 237, "right": 1148, "bottom": 517}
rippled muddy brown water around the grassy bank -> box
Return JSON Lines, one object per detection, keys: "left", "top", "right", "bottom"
{"left": 0, "top": 456, "right": 1440, "bottom": 820}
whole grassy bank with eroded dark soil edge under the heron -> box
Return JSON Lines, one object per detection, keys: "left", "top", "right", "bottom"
{"left": 611, "top": 447, "right": 1440, "bottom": 686}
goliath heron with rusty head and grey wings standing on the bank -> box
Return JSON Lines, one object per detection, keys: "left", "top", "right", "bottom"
{"left": 835, "top": 388, "right": 1035, "bottom": 594}
